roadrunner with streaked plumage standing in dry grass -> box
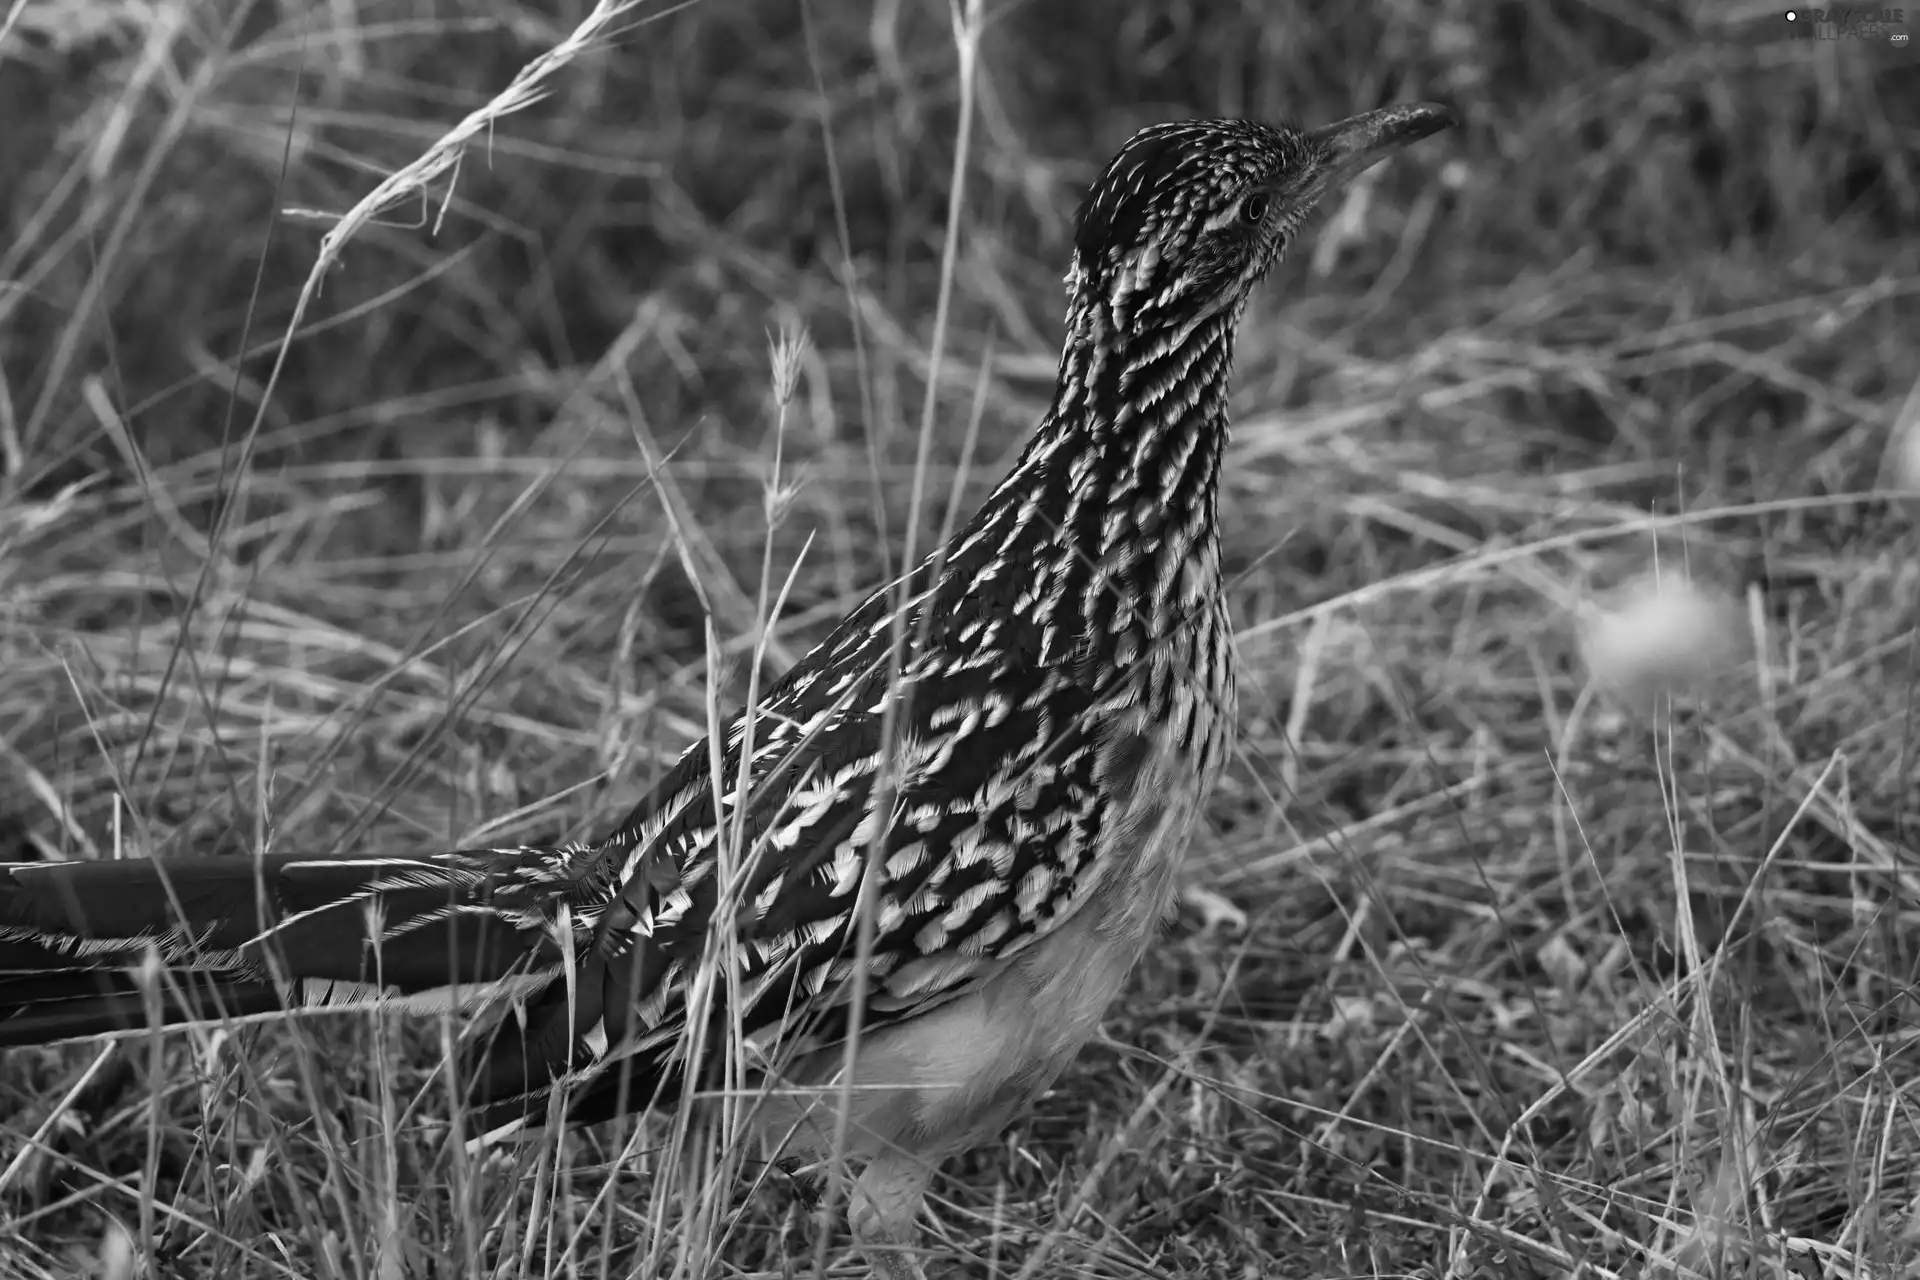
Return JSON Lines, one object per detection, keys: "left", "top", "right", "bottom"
{"left": 0, "top": 104, "right": 1457, "bottom": 1280}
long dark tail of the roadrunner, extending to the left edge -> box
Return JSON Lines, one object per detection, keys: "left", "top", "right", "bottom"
{"left": 0, "top": 848, "right": 563, "bottom": 1046}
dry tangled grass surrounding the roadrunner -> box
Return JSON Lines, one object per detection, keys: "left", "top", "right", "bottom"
{"left": 0, "top": 0, "right": 1920, "bottom": 1280}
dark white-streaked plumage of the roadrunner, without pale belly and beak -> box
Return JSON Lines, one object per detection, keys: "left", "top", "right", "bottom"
{"left": 0, "top": 121, "right": 1311, "bottom": 1121}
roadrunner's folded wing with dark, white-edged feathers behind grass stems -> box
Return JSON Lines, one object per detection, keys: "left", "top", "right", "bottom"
{"left": 476, "top": 579, "right": 1131, "bottom": 1119}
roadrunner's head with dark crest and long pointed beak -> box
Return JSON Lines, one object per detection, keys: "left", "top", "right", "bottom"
{"left": 1068, "top": 104, "right": 1457, "bottom": 340}
